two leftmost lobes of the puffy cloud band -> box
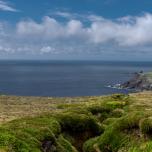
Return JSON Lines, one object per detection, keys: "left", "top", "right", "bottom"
{"left": 17, "top": 16, "right": 64, "bottom": 40}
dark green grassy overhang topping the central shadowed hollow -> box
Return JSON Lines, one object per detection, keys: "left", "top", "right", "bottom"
{"left": 57, "top": 112, "right": 102, "bottom": 134}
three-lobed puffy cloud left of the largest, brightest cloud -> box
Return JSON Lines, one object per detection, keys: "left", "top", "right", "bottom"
{"left": 16, "top": 16, "right": 85, "bottom": 41}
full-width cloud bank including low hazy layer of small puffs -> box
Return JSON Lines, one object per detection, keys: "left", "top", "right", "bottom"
{"left": 0, "top": 13, "right": 152, "bottom": 54}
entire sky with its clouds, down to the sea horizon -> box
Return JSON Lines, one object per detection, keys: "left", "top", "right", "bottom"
{"left": 0, "top": 0, "right": 152, "bottom": 60}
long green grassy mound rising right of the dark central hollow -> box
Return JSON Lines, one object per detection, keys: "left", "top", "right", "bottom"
{"left": 84, "top": 113, "right": 143, "bottom": 152}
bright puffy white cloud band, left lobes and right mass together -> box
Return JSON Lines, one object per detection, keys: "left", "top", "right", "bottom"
{"left": 17, "top": 14, "right": 152, "bottom": 46}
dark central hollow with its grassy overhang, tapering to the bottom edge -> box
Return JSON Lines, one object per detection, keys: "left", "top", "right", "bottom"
{"left": 56, "top": 111, "right": 103, "bottom": 151}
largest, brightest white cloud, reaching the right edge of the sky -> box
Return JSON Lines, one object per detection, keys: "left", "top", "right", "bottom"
{"left": 88, "top": 14, "right": 152, "bottom": 46}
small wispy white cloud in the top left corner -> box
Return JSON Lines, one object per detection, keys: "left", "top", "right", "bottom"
{"left": 0, "top": 0, "right": 18, "bottom": 12}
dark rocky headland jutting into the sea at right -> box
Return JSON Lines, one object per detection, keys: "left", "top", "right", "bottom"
{"left": 121, "top": 71, "right": 152, "bottom": 90}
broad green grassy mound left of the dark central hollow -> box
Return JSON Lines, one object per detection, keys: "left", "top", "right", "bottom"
{"left": 0, "top": 117, "right": 74, "bottom": 152}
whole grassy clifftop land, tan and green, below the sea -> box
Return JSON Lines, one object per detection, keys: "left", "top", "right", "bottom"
{"left": 0, "top": 92, "right": 152, "bottom": 152}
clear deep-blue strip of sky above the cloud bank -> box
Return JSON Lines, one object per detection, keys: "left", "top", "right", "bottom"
{"left": 0, "top": 0, "right": 152, "bottom": 22}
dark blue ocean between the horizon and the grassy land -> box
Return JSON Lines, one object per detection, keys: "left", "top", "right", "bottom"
{"left": 0, "top": 60, "right": 152, "bottom": 97}
